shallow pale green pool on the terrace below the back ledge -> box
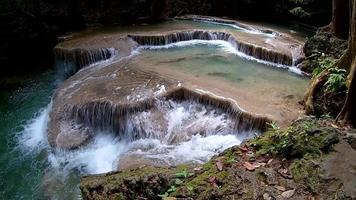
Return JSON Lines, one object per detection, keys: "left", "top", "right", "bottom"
{"left": 134, "top": 40, "right": 308, "bottom": 102}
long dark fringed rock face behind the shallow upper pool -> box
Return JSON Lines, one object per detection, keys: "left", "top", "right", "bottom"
{"left": 129, "top": 30, "right": 293, "bottom": 66}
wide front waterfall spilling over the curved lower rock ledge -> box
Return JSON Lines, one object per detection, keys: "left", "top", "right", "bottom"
{"left": 56, "top": 87, "right": 270, "bottom": 148}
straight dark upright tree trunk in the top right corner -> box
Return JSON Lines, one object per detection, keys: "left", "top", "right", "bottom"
{"left": 332, "top": 0, "right": 350, "bottom": 39}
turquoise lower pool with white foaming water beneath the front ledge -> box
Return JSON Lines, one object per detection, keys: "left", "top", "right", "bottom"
{"left": 0, "top": 71, "right": 247, "bottom": 199}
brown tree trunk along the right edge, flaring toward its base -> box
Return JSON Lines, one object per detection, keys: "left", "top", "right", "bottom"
{"left": 337, "top": 0, "right": 356, "bottom": 127}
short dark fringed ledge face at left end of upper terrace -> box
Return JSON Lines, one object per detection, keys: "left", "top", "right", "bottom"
{"left": 54, "top": 47, "right": 117, "bottom": 70}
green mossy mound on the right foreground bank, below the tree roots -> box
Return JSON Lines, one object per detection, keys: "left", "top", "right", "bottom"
{"left": 250, "top": 117, "right": 339, "bottom": 159}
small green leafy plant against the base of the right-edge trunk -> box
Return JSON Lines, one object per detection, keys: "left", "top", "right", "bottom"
{"left": 324, "top": 68, "right": 346, "bottom": 92}
